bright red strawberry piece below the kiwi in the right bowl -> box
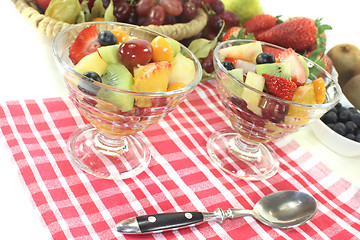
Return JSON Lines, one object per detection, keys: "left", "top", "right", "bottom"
{"left": 262, "top": 73, "right": 297, "bottom": 101}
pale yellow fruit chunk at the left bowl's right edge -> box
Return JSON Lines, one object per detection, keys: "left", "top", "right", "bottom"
{"left": 169, "top": 53, "right": 195, "bottom": 85}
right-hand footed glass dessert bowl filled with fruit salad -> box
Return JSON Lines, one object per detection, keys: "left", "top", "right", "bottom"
{"left": 207, "top": 40, "right": 341, "bottom": 180}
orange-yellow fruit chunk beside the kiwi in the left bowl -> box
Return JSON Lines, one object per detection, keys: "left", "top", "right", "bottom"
{"left": 134, "top": 61, "right": 171, "bottom": 92}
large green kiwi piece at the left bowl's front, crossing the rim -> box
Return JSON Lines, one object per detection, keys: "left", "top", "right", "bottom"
{"left": 97, "top": 63, "right": 134, "bottom": 112}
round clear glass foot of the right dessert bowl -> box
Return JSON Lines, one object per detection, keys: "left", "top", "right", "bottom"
{"left": 206, "top": 129, "right": 279, "bottom": 181}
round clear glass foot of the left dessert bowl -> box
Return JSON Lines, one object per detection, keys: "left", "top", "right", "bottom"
{"left": 68, "top": 126, "right": 151, "bottom": 180}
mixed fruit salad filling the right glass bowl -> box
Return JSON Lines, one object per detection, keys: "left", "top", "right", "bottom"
{"left": 212, "top": 41, "right": 338, "bottom": 142}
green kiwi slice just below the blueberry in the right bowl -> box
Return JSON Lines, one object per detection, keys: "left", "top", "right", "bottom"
{"left": 256, "top": 62, "right": 291, "bottom": 80}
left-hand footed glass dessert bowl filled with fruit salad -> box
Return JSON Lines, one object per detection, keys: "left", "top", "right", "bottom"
{"left": 53, "top": 22, "right": 201, "bottom": 180}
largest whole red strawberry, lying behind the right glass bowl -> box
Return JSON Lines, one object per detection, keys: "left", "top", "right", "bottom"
{"left": 255, "top": 18, "right": 318, "bottom": 52}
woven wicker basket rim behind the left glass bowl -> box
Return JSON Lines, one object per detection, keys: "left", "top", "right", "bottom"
{"left": 11, "top": 0, "right": 207, "bottom": 40}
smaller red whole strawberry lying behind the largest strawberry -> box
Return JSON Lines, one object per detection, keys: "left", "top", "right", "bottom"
{"left": 243, "top": 14, "right": 279, "bottom": 33}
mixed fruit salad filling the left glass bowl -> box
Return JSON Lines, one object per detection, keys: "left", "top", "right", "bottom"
{"left": 59, "top": 23, "right": 201, "bottom": 135}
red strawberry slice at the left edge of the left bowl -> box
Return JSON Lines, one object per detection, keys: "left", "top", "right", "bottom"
{"left": 69, "top": 24, "right": 101, "bottom": 64}
